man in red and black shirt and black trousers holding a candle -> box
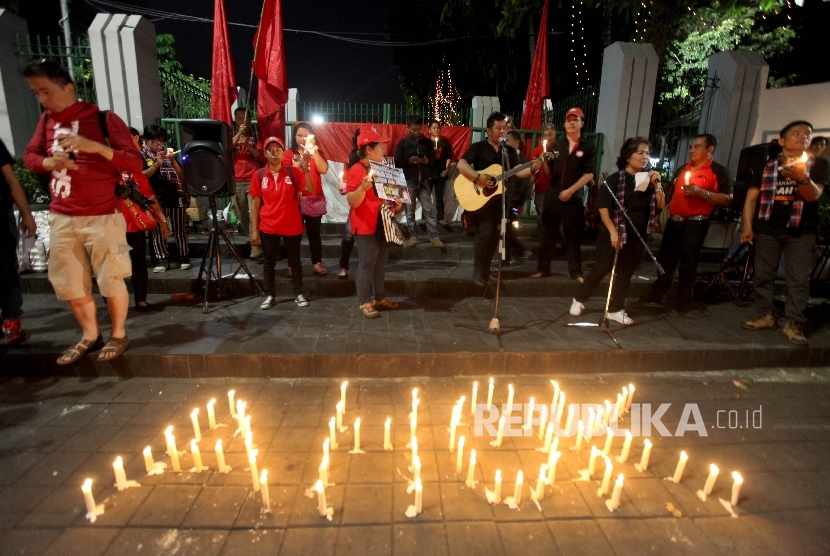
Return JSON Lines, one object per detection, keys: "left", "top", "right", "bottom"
{"left": 643, "top": 133, "right": 732, "bottom": 312}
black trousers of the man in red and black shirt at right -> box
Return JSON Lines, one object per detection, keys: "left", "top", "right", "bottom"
{"left": 649, "top": 219, "right": 709, "bottom": 304}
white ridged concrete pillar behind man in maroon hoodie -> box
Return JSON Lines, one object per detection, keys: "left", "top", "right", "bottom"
{"left": 89, "top": 14, "right": 164, "bottom": 129}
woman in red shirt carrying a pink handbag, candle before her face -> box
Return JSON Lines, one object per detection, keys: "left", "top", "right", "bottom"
{"left": 282, "top": 122, "right": 329, "bottom": 276}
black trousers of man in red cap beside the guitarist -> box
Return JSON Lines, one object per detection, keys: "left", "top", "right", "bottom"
{"left": 536, "top": 199, "right": 585, "bottom": 277}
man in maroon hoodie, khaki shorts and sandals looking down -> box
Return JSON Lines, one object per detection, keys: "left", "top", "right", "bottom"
{"left": 23, "top": 60, "right": 144, "bottom": 365}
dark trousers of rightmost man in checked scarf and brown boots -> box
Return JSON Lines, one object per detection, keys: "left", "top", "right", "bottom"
{"left": 752, "top": 231, "right": 816, "bottom": 323}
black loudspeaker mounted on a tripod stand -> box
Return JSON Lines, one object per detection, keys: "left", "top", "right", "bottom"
{"left": 179, "top": 120, "right": 236, "bottom": 197}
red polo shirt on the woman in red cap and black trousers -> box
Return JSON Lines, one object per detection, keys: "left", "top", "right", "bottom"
{"left": 254, "top": 166, "right": 303, "bottom": 236}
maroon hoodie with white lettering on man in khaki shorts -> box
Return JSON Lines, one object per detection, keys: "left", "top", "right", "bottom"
{"left": 23, "top": 100, "right": 144, "bottom": 216}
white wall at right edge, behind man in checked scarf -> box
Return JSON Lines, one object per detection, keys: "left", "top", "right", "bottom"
{"left": 747, "top": 81, "right": 830, "bottom": 146}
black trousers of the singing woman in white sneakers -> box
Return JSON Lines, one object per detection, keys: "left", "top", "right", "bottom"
{"left": 576, "top": 226, "right": 645, "bottom": 313}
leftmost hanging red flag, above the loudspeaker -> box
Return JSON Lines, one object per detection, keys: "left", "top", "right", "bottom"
{"left": 210, "top": 0, "right": 237, "bottom": 126}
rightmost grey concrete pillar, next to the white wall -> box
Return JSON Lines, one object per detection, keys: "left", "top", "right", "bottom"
{"left": 698, "top": 50, "right": 772, "bottom": 176}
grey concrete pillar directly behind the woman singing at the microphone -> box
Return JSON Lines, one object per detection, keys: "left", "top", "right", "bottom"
{"left": 597, "top": 42, "right": 657, "bottom": 173}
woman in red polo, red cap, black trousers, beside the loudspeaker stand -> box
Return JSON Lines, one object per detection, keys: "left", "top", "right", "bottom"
{"left": 248, "top": 137, "right": 313, "bottom": 309}
